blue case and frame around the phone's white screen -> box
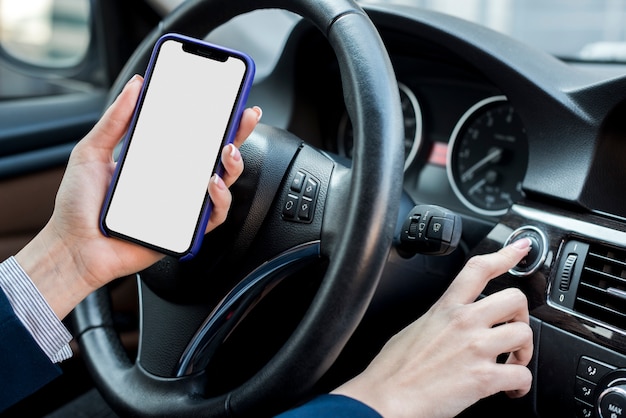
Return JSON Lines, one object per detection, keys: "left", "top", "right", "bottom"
{"left": 100, "top": 33, "right": 255, "bottom": 260}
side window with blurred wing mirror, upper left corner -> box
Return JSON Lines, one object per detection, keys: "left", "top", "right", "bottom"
{"left": 0, "top": 0, "right": 95, "bottom": 100}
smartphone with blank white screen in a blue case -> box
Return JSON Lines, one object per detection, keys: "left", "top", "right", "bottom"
{"left": 100, "top": 34, "right": 255, "bottom": 260}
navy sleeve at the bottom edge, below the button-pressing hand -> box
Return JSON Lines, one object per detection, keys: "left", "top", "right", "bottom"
{"left": 278, "top": 395, "right": 382, "bottom": 418}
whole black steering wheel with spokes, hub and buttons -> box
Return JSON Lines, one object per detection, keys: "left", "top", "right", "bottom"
{"left": 73, "top": 0, "right": 403, "bottom": 417}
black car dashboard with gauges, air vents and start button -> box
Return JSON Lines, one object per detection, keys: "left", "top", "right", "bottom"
{"left": 241, "top": 6, "right": 626, "bottom": 417}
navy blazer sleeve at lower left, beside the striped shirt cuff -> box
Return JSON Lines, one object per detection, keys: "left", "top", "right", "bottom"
{"left": 0, "top": 290, "right": 61, "bottom": 412}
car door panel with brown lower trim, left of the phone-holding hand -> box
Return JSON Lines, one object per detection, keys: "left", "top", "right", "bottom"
{"left": 0, "top": 91, "right": 106, "bottom": 259}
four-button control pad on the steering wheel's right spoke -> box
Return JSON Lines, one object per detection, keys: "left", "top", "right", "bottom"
{"left": 283, "top": 171, "right": 320, "bottom": 223}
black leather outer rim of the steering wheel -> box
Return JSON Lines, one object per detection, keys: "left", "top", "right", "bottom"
{"left": 74, "top": 0, "right": 403, "bottom": 416}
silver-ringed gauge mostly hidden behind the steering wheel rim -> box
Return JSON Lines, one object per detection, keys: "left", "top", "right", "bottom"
{"left": 337, "top": 83, "right": 422, "bottom": 171}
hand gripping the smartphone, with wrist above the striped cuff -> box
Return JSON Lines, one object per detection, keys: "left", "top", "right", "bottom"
{"left": 15, "top": 76, "right": 261, "bottom": 319}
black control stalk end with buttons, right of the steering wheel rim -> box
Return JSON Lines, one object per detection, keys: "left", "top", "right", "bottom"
{"left": 398, "top": 205, "right": 462, "bottom": 257}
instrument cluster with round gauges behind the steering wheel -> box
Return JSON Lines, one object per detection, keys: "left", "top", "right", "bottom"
{"left": 336, "top": 83, "right": 528, "bottom": 218}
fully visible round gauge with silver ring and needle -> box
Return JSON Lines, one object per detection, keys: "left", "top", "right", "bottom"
{"left": 447, "top": 96, "right": 528, "bottom": 216}
